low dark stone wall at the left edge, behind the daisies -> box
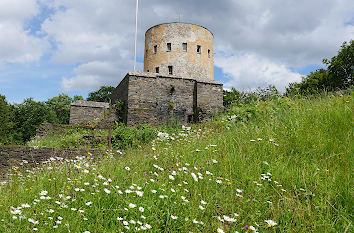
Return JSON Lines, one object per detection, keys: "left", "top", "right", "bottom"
{"left": 0, "top": 146, "right": 105, "bottom": 178}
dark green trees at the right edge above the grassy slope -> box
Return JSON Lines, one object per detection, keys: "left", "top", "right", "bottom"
{"left": 286, "top": 40, "right": 354, "bottom": 95}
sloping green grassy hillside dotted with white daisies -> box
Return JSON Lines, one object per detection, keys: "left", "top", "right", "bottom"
{"left": 0, "top": 95, "right": 354, "bottom": 232}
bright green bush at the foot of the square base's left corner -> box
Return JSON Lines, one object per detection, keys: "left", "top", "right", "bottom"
{"left": 112, "top": 123, "right": 157, "bottom": 149}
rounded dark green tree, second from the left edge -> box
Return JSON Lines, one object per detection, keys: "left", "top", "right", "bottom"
{"left": 13, "top": 98, "right": 58, "bottom": 142}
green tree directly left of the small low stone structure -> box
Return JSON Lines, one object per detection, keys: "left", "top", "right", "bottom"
{"left": 45, "top": 94, "right": 73, "bottom": 124}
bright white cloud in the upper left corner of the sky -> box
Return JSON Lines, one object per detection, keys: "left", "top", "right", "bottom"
{"left": 0, "top": 0, "right": 48, "bottom": 65}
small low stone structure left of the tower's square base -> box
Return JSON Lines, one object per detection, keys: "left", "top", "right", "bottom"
{"left": 70, "top": 100, "right": 109, "bottom": 124}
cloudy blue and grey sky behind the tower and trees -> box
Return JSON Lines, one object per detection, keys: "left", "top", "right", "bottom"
{"left": 0, "top": 0, "right": 354, "bottom": 103}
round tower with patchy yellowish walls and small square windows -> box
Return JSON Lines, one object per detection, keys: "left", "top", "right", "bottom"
{"left": 144, "top": 23, "right": 214, "bottom": 80}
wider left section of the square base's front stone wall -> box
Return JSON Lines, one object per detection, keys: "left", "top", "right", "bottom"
{"left": 127, "top": 76, "right": 194, "bottom": 125}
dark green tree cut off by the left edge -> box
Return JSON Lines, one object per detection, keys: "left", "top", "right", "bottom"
{"left": 0, "top": 95, "right": 14, "bottom": 144}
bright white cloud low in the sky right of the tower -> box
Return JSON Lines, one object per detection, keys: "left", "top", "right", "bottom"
{"left": 215, "top": 54, "right": 301, "bottom": 91}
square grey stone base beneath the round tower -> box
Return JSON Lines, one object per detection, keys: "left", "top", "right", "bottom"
{"left": 112, "top": 72, "right": 223, "bottom": 126}
